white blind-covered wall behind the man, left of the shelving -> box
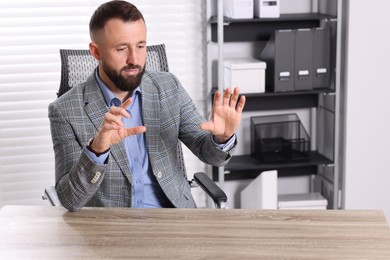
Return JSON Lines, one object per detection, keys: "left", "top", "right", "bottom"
{"left": 0, "top": 0, "right": 205, "bottom": 207}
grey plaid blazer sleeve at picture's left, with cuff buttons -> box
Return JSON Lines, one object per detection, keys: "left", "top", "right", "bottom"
{"left": 49, "top": 100, "right": 106, "bottom": 211}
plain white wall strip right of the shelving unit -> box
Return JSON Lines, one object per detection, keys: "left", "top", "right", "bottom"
{"left": 343, "top": 0, "right": 390, "bottom": 221}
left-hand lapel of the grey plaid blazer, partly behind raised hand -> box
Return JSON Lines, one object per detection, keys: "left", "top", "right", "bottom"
{"left": 84, "top": 73, "right": 131, "bottom": 183}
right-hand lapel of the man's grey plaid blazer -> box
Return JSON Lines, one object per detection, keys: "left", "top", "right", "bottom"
{"left": 141, "top": 73, "right": 160, "bottom": 165}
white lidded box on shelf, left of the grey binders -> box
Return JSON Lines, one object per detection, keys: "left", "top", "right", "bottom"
{"left": 224, "top": 58, "right": 266, "bottom": 93}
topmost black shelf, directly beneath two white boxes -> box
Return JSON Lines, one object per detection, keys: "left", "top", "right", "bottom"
{"left": 210, "top": 13, "right": 336, "bottom": 42}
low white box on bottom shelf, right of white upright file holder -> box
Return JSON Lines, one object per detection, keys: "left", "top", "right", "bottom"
{"left": 278, "top": 192, "right": 328, "bottom": 210}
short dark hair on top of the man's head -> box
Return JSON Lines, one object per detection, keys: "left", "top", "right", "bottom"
{"left": 89, "top": 0, "right": 145, "bottom": 36}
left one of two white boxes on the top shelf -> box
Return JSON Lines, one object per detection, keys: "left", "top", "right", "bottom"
{"left": 223, "top": 0, "right": 253, "bottom": 19}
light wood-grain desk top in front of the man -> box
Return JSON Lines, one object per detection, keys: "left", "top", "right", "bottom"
{"left": 0, "top": 206, "right": 390, "bottom": 260}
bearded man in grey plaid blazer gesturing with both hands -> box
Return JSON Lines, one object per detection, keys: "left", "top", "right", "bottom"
{"left": 49, "top": 1, "right": 245, "bottom": 211}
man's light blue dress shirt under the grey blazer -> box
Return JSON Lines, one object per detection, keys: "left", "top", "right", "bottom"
{"left": 85, "top": 70, "right": 236, "bottom": 208}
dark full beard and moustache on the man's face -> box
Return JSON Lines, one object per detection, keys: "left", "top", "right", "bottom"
{"left": 102, "top": 62, "right": 146, "bottom": 95}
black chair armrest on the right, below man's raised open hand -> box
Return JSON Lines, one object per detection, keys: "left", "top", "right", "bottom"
{"left": 194, "top": 172, "right": 227, "bottom": 208}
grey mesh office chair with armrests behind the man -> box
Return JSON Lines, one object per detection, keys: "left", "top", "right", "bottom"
{"left": 42, "top": 44, "right": 227, "bottom": 208}
